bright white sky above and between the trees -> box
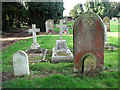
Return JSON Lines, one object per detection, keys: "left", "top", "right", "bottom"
{"left": 63, "top": 0, "right": 120, "bottom": 16}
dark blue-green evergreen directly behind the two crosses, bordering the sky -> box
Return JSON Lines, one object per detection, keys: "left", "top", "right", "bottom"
{"left": 26, "top": 2, "right": 64, "bottom": 32}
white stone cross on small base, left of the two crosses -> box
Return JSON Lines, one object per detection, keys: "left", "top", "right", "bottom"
{"left": 28, "top": 24, "right": 40, "bottom": 49}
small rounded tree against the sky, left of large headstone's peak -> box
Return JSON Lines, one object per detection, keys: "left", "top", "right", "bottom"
{"left": 70, "top": 4, "right": 84, "bottom": 18}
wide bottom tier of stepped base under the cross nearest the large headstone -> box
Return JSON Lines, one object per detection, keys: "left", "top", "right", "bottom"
{"left": 51, "top": 47, "right": 74, "bottom": 63}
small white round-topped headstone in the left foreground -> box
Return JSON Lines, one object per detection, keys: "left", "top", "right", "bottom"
{"left": 13, "top": 51, "right": 30, "bottom": 76}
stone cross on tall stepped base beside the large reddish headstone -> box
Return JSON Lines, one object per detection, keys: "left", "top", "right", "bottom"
{"left": 51, "top": 20, "right": 73, "bottom": 62}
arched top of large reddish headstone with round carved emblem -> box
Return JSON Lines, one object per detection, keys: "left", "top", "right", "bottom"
{"left": 74, "top": 11, "right": 104, "bottom": 32}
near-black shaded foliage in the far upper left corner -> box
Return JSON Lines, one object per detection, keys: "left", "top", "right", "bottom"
{"left": 2, "top": 2, "right": 25, "bottom": 32}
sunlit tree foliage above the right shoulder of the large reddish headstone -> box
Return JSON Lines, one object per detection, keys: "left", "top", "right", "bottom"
{"left": 85, "top": 0, "right": 120, "bottom": 18}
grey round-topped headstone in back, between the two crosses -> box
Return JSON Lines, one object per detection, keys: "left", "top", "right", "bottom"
{"left": 45, "top": 19, "right": 54, "bottom": 33}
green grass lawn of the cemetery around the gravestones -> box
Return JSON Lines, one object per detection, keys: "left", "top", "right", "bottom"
{"left": 2, "top": 21, "right": 120, "bottom": 88}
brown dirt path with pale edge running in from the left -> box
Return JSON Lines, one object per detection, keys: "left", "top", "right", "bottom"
{"left": 0, "top": 35, "right": 46, "bottom": 51}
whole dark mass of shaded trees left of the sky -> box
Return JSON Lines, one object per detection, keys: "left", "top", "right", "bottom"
{"left": 2, "top": 2, "right": 64, "bottom": 32}
